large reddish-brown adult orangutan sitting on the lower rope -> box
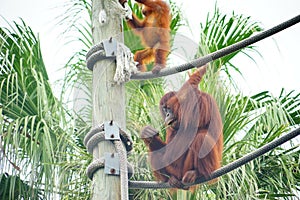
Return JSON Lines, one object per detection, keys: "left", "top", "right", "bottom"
{"left": 141, "top": 67, "right": 223, "bottom": 189}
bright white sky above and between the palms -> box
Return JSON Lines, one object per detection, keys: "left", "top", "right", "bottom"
{"left": 0, "top": 0, "right": 300, "bottom": 96}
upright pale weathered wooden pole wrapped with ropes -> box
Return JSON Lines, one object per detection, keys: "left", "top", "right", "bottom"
{"left": 92, "top": 0, "right": 125, "bottom": 200}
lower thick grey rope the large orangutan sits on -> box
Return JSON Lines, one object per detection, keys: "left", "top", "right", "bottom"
{"left": 129, "top": 128, "right": 300, "bottom": 189}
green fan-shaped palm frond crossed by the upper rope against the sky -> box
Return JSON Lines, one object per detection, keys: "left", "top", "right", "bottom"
{"left": 196, "top": 7, "right": 262, "bottom": 78}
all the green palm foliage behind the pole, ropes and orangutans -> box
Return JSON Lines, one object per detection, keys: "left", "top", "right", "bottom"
{"left": 0, "top": 0, "right": 300, "bottom": 199}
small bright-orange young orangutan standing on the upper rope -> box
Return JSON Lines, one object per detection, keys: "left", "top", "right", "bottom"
{"left": 127, "top": 0, "right": 171, "bottom": 73}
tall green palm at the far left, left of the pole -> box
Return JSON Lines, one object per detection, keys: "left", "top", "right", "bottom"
{"left": 0, "top": 21, "right": 69, "bottom": 199}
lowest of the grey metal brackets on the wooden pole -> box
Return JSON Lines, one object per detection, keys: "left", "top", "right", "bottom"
{"left": 104, "top": 152, "right": 120, "bottom": 175}
